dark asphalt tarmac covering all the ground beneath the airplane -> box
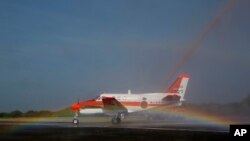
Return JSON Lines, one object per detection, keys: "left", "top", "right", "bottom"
{"left": 0, "top": 122, "right": 229, "bottom": 141}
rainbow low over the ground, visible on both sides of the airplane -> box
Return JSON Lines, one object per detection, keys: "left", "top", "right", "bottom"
{"left": 0, "top": 107, "right": 234, "bottom": 135}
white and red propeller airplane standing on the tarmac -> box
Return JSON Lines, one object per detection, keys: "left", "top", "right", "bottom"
{"left": 71, "top": 74, "right": 190, "bottom": 125}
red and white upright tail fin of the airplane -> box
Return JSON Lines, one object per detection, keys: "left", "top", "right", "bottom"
{"left": 167, "top": 74, "right": 190, "bottom": 101}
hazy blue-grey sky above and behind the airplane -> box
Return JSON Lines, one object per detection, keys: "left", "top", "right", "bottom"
{"left": 0, "top": 0, "right": 250, "bottom": 111}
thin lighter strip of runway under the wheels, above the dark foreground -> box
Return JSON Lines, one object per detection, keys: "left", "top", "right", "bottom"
{"left": 0, "top": 122, "right": 229, "bottom": 132}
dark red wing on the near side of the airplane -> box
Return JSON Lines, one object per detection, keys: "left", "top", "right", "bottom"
{"left": 102, "top": 97, "right": 127, "bottom": 113}
